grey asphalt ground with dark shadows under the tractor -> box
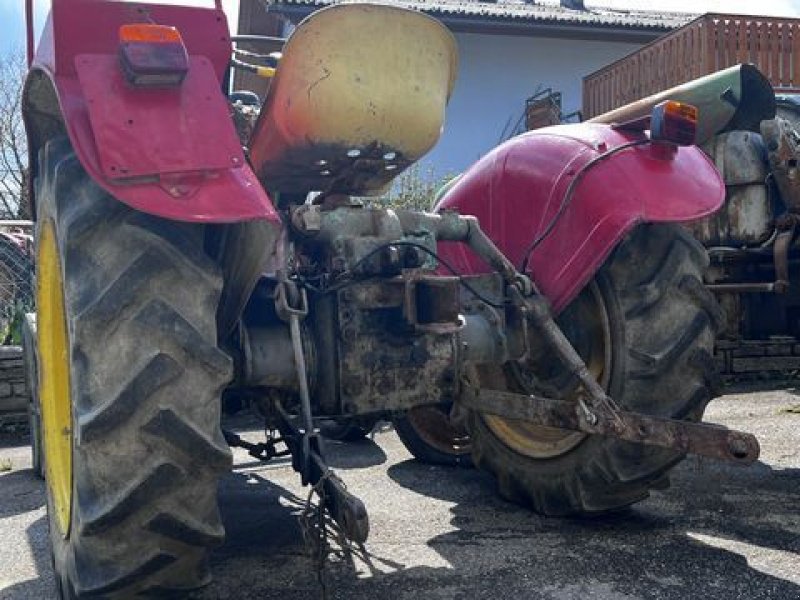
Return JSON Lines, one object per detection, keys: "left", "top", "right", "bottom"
{"left": 0, "top": 388, "right": 800, "bottom": 600}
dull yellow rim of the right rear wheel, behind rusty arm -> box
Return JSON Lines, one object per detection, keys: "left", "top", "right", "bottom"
{"left": 482, "top": 283, "right": 611, "bottom": 459}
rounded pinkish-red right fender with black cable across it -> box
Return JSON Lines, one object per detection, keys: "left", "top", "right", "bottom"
{"left": 436, "top": 123, "right": 725, "bottom": 312}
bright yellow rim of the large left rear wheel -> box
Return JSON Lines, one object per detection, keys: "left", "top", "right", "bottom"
{"left": 36, "top": 223, "right": 72, "bottom": 537}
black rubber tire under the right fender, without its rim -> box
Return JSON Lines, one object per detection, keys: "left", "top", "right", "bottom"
{"left": 470, "top": 224, "right": 723, "bottom": 515}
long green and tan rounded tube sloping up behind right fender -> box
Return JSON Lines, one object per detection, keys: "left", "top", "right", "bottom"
{"left": 588, "top": 64, "right": 775, "bottom": 145}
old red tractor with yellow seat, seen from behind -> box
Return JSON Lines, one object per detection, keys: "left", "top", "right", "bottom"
{"left": 23, "top": 0, "right": 758, "bottom": 598}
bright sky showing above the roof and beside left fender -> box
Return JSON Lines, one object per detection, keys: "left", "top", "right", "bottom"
{"left": 0, "top": 0, "right": 800, "bottom": 52}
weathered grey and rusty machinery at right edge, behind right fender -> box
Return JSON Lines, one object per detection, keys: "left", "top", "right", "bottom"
{"left": 690, "top": 78, "right": 800, "bottom": 379}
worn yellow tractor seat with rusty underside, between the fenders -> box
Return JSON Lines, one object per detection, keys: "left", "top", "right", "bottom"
{"left": 250, "top": 4, "right": 457, "bottom": 195}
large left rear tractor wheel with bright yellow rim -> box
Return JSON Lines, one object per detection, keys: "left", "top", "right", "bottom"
{"left": 36, "top": 138, "right": 232, "bottom": 599}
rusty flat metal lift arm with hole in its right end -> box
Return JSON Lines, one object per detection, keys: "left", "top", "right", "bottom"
{"left": 459, "top": 382, "right": 759, "bottom": 465}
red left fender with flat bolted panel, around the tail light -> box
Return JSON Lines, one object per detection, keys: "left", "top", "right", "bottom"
{"left": 23, "top": 0, "right": 279, "bottom": 223}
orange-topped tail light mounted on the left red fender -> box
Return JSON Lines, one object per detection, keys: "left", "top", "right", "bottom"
{"left": 119, "top": 23, "right": 189, "bottom": 87}
